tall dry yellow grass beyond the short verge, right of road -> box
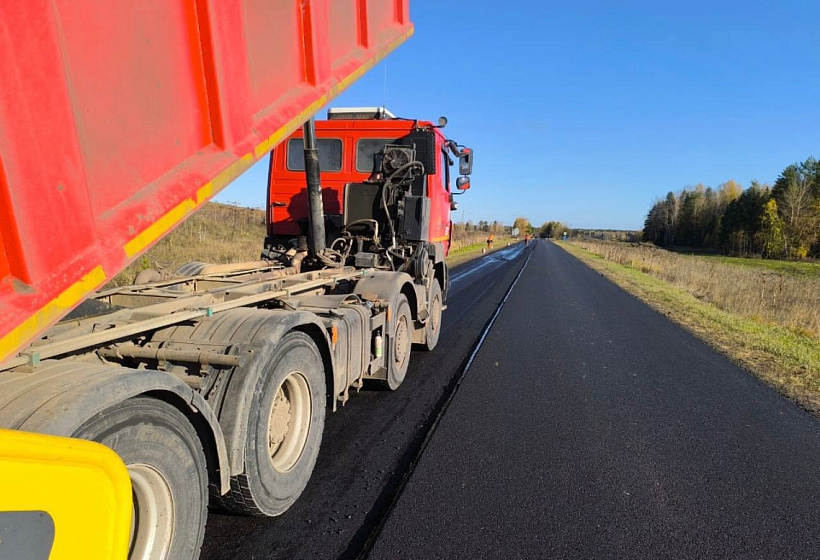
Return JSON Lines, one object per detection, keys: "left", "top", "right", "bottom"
{"left": 573, "top": 240, "right": 820, "bottom": 336}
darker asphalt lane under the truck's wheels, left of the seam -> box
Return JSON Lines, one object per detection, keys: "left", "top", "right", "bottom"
{"left": 200, "top": 245, "right": 523, "bottom": 560}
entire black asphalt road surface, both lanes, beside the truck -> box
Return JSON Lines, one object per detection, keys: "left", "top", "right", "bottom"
{"left": 202, "top": 241, "right": 820, "bottom": 560}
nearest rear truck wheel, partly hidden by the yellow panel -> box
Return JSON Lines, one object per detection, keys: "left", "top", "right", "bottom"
{"left": 74, "top": 397, "right": 208, "bottom": 560}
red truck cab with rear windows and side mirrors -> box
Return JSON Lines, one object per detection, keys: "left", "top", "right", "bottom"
{"left": 268, "top": 108, "right": 472, "bottom": 255}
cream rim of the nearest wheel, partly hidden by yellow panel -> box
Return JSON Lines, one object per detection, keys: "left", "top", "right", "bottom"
{"left": 128, "top": 464, "right": 174, "bottom": 560}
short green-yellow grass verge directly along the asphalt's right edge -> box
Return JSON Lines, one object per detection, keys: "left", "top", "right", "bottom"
{"left": 556, "top": 243, "right": 820, "bottom": 416}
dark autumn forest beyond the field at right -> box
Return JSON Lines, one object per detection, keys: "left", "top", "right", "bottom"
{"left": 643, "top": 158, "right": 820, "bottom": 259}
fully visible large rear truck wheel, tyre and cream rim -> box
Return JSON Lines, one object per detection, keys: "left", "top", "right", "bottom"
{"left": 215, "top": 332, "right": 325, "bottom": 516}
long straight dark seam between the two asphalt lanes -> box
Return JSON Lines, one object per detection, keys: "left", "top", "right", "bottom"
{"left": 350, "top": 245, "right": 535, "bottom": 560}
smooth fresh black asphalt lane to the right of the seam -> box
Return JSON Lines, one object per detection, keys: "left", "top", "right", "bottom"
{"left": 369, "top": 241, "right": 820, "bottom": 559}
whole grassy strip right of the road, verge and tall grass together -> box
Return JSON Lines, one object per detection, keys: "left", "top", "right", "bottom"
{"left": 556, "top": 242, "right": 820, "bottom": 415}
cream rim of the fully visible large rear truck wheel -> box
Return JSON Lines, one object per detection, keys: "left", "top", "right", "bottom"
{"left": 268, "top": 371, "right": 313, "bottom": 473}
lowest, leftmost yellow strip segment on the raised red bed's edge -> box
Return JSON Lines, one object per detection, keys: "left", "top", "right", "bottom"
{"left": 0, "top": 266, "right": 105, "bottom": 363}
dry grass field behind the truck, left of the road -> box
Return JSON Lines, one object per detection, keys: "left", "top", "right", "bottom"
{"left": 109, "top": 202, "right": 510, "bottom": 286}
